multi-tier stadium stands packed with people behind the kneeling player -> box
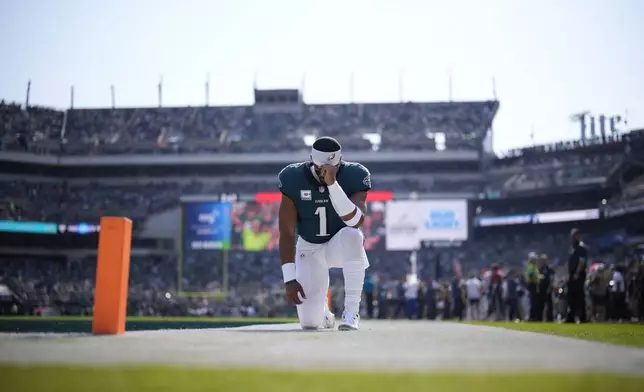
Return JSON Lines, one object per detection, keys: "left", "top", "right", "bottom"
{"left": 0, "top": 96, "right": 644, "bottom": 317}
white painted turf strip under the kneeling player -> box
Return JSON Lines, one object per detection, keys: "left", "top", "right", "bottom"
{"left": 5, "top": 320, "right": 644, "bottom": 379}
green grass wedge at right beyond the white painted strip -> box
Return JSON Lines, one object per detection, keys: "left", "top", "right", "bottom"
{"left": 469, "top": 322, "right": 644, "bottom": 348}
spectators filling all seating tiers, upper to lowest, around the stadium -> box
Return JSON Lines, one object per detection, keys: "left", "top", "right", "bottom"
{"left": 0, "top": 98, "right": 644, "bottom": 322}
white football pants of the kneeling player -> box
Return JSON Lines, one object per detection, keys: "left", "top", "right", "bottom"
{"left": 295, "top": 227, "right": 369, "bottom": 329}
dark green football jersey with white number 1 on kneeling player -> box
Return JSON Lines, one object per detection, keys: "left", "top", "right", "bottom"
{"left": 278, "top": 162, "right": 371, "bottom": 244}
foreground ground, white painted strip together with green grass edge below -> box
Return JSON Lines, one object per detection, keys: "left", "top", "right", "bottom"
{"left": 0, "top": 320, "right": 644, "bottom": 392}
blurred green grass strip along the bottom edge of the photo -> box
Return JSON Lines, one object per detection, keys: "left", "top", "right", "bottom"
{"left": 0, "top": 366, "right": 644, "bottom": 392}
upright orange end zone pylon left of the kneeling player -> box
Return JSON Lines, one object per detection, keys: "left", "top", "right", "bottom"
{"left": 92, "top": 217, "right": 132, "bottom": 335}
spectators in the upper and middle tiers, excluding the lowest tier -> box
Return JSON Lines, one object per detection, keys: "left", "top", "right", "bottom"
{"left": 0, "top": 102, "right": 630, "bottom": 225}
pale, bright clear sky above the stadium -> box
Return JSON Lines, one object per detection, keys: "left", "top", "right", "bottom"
{"left": 0, "top": 0, "right": 644, "bottom": 151}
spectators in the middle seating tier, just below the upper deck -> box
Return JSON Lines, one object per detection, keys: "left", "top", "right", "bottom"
{"left": 0, "top": 157, "right": 620, "bottom": 222}
